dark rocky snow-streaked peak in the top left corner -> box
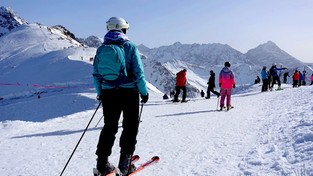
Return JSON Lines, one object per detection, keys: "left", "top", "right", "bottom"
{"left": 0, "top": 6, "right": 27, "bottom": 37}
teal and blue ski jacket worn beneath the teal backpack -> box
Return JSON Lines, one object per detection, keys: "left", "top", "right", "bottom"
{"left": 93, "top": 31, "right": 148, "bottom": 95}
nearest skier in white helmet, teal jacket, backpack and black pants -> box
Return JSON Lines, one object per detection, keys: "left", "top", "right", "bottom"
{"left": 93, "top": 17, "right": 149, "bottom": 176}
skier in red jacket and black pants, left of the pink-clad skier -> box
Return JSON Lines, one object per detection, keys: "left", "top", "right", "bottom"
{"left": 173, "top": 69, "right": 187, "bottom": 103}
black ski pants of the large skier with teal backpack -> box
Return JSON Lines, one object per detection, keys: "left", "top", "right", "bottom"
{"left": 96, "top": 88, "right": 139, "bottom": 158}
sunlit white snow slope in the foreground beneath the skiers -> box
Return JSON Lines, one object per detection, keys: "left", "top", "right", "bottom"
{"left": 0, "top": 85, "right": 313, "bottom": 176}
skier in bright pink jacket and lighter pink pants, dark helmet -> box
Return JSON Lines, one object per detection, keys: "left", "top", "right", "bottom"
{"left": 219, "top": 62, "right": 236, "bottom": 110}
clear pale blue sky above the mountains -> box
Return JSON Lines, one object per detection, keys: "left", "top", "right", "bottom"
{"left": 0, "top": 0, "right": 313, "bottom": 62}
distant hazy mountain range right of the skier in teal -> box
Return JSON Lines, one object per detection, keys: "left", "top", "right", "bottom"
{"left": 139, "top": 41, "right": 312, "bottom": 93}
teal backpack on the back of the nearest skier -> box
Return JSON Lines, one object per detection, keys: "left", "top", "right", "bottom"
{"left": 95, "top": 44, "right": 127, "bottom": 86}
